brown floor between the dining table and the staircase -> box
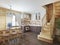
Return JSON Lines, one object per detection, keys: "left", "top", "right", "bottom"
{"left": 20, "top": 32, "right": 60, "bottom": 45}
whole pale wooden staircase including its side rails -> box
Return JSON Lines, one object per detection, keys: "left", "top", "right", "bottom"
{"left": 37, "top": 15, "right": 54, "bottom": 43}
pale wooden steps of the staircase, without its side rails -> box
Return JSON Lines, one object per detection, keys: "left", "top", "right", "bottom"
{"left": 38, "top": 23, "right": 53, "bottom": 43}
